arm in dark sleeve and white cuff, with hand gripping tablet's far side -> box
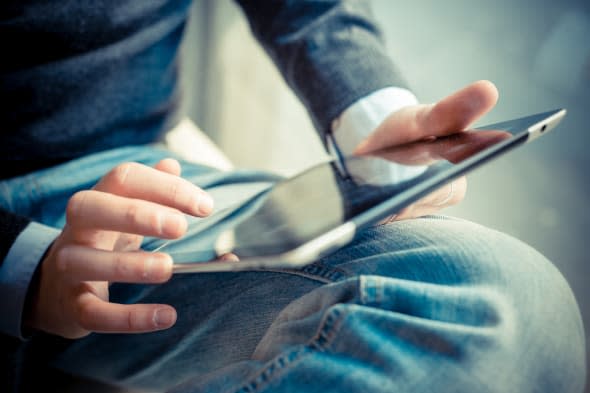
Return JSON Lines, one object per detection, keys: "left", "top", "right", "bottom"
{"left": 238, "top": 0, "right": 498, "bottom": 219}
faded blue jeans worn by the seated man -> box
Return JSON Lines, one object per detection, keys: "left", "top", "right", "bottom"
{"left": 5, "top": 147, "right": 586, "bottom": 393}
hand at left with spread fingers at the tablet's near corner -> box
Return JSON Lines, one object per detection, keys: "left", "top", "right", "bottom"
{"left": 26, "top": 159, "right": 212, "bottom": 338}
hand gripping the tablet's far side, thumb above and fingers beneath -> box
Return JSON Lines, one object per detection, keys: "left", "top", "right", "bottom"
{"left": 354, "top": 81, "right": 498, "bottom": 221}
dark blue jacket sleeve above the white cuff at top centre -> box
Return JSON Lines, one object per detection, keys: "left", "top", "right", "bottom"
{"left": 237, "top": 0, "right": 406, "bottom": 133}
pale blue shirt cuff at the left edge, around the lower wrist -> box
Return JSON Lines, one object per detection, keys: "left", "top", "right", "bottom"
{"left": 0, "top": 222, "right": 60, "bottom": 339}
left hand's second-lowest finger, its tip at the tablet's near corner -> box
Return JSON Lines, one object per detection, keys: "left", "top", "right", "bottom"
{"left": 56, "top": 246, "right": 172, "bottom": 283}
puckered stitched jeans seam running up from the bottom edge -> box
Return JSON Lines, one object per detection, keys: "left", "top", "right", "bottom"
{"left": 235, "top": 305, "right": 346, "bottom": 393}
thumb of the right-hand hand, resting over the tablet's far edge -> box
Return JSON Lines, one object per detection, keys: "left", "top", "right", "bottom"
{"left": 354, "top": 81, "right": 498, "bottom": 154}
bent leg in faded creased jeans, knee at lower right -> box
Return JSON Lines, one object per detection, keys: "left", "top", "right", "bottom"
{"left": 214, "top": 219, "right": 585, "bottom": 392}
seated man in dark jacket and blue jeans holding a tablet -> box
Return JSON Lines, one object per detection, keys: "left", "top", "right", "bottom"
{"left": 0, "top": 0, "right": 584, "bottom": 392}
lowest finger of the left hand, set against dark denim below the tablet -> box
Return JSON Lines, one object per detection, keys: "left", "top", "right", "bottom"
{"left": 76, "top": 293, "right": 176, "bottom": 333}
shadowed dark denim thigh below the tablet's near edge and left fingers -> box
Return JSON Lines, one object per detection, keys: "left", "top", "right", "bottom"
{"left": 48, "top": 272, "right": 322, "bottom": 390}
